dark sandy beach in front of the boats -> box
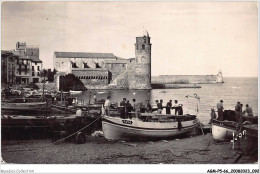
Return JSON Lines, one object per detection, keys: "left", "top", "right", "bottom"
{"left": 2, "top": 133, "right": 258, "bottom": 164}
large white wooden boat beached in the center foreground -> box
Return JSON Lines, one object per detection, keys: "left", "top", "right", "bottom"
{"left": 102, "top": 113, "right": 197, "bottom": 140}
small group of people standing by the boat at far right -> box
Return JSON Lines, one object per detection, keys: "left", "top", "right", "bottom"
{"left": 217, "top": 100, "right": 253, "bottom": 121}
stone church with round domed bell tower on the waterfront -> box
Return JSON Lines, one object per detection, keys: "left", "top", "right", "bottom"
{"left": 53, "top": 33, "right": 151, "bottom": 90}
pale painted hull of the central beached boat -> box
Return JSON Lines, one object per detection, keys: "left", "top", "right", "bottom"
{"left": 102, "top": 116, "right": 197, "bottom": 140}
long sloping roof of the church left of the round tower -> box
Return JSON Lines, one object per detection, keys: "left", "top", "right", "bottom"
{"left": 54, "top": 52, "right": 116, "bottom": 59}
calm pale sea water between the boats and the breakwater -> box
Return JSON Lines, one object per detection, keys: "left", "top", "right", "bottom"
{"left": 75, "top": 77, "right": 258, "bottom": 124}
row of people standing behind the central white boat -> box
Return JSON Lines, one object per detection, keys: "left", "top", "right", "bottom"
{"left": 104, "top": 96, "right": 183, "bottom": 119}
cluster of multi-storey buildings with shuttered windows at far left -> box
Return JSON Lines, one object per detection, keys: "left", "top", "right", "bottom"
{"left": 1, "top": 42, "right": 42, "bottom": 84}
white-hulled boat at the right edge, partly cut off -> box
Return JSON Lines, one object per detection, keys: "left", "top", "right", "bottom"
{"left": 212, "top": 110, "right": 257, "bottom": 140}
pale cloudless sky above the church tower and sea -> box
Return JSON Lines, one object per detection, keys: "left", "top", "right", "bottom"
{"left": 1, "top": 2, "right": 258, "bottom": 77}
